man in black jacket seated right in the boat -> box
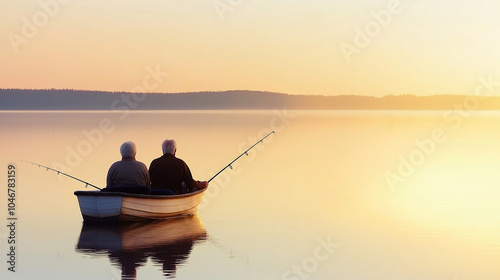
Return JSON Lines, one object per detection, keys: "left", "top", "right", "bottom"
{"left": 149, "top": 139, "right": 208, "bottom": 194}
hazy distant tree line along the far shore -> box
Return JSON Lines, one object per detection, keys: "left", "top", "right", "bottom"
{"left": 0, "top": 89, "right": 500, "bottom": 110}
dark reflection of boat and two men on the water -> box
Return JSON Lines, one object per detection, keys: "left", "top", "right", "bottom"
{"left": 76, "top": 215, "right": 207, "bottom": 279}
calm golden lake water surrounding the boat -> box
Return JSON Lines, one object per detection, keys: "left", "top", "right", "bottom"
{"left": 0, "top": 111, "right": 500, "bottom": 280}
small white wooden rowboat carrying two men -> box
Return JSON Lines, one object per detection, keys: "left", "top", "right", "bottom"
{"left": 75, "top": 188, "right": 206, "bottom": 222}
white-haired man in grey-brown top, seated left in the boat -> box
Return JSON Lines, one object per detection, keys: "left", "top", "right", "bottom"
{"left": 106, "top": 141, "right": 150, "bottom": 190}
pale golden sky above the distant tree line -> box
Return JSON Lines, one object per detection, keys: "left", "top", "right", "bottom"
{"left": 0, "top": 0, "right": 500, "bottom": 96}
